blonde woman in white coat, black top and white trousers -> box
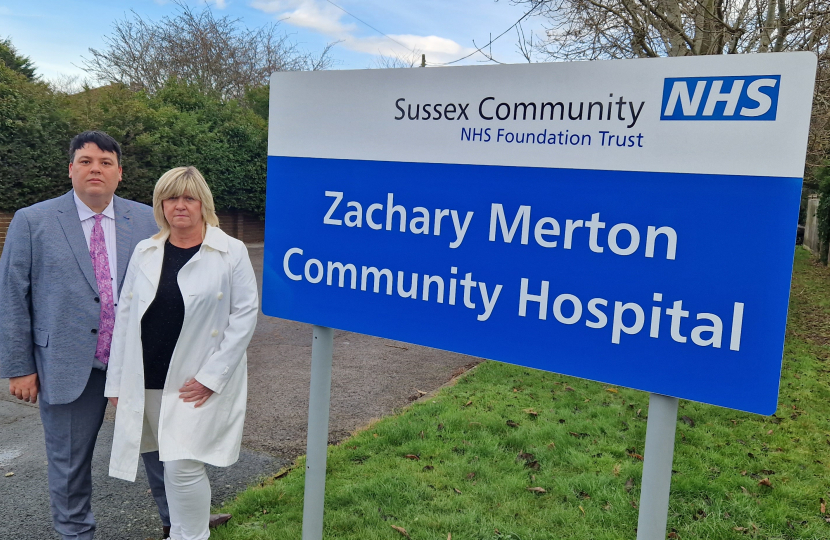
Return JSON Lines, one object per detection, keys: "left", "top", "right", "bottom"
{"left": 105, "top": 167, "right": 258, "bottom": 540}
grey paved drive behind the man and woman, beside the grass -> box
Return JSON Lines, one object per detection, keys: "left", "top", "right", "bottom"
{"left": 0, "top": 248, "right": 478, "bottom": 540}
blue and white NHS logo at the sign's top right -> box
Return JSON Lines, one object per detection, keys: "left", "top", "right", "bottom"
{"left": 660, "top": 75, "right": 781, "bottom": 120}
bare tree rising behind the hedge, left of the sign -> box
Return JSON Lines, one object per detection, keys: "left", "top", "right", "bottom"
{"left": 83, "top": 0, "right": 335, "bottom": 98}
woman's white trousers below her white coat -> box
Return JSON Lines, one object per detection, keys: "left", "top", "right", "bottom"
{"left": 144, "top": 390, "right": 210, "bottom": 540}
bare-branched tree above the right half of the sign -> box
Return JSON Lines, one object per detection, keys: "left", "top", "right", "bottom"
{"left": 512, "top": 0, "right": 830, "bottom": 60}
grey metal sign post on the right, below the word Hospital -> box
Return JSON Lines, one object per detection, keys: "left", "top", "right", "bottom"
{"left": 637, "top": 394, "right": 679, "bottom": 540}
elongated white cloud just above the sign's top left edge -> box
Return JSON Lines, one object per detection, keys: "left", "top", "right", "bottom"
{"left": 251, "top": 0, "right": 474, "bottom": 63}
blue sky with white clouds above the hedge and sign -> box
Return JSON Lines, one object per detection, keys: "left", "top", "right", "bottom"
{"left": 0, "top": 0, "right": 543, "bottom": 84}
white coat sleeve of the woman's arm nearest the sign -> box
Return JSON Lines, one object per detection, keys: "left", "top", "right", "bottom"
{"left": 195, "top": 242, "right": 259, "bottom": 394}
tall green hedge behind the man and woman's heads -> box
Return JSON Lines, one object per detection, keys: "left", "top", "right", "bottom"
{"left": 0, "top": 69, "right": 268, "bottom": 217}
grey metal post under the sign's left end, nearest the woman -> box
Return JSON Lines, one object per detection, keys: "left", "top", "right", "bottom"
{"left": 303, "top": 326, "right": 334, "bottom": 540}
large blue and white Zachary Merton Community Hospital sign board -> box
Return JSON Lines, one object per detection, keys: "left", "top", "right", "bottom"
{"left": 263, "top": 55, "right": 815, "bottom": 414}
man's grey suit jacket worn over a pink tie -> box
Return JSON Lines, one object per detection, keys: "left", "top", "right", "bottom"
{"left": 0, "top": 191, "right": 158, "bottom": 405}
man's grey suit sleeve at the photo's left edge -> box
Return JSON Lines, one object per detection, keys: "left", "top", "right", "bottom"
{"left": 0, "top": 211, "right": 37, "bottom": 378}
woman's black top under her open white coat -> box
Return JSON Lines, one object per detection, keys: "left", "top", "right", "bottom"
{"left": 141, "top": 240, "right": 201, "bottom": 390}
